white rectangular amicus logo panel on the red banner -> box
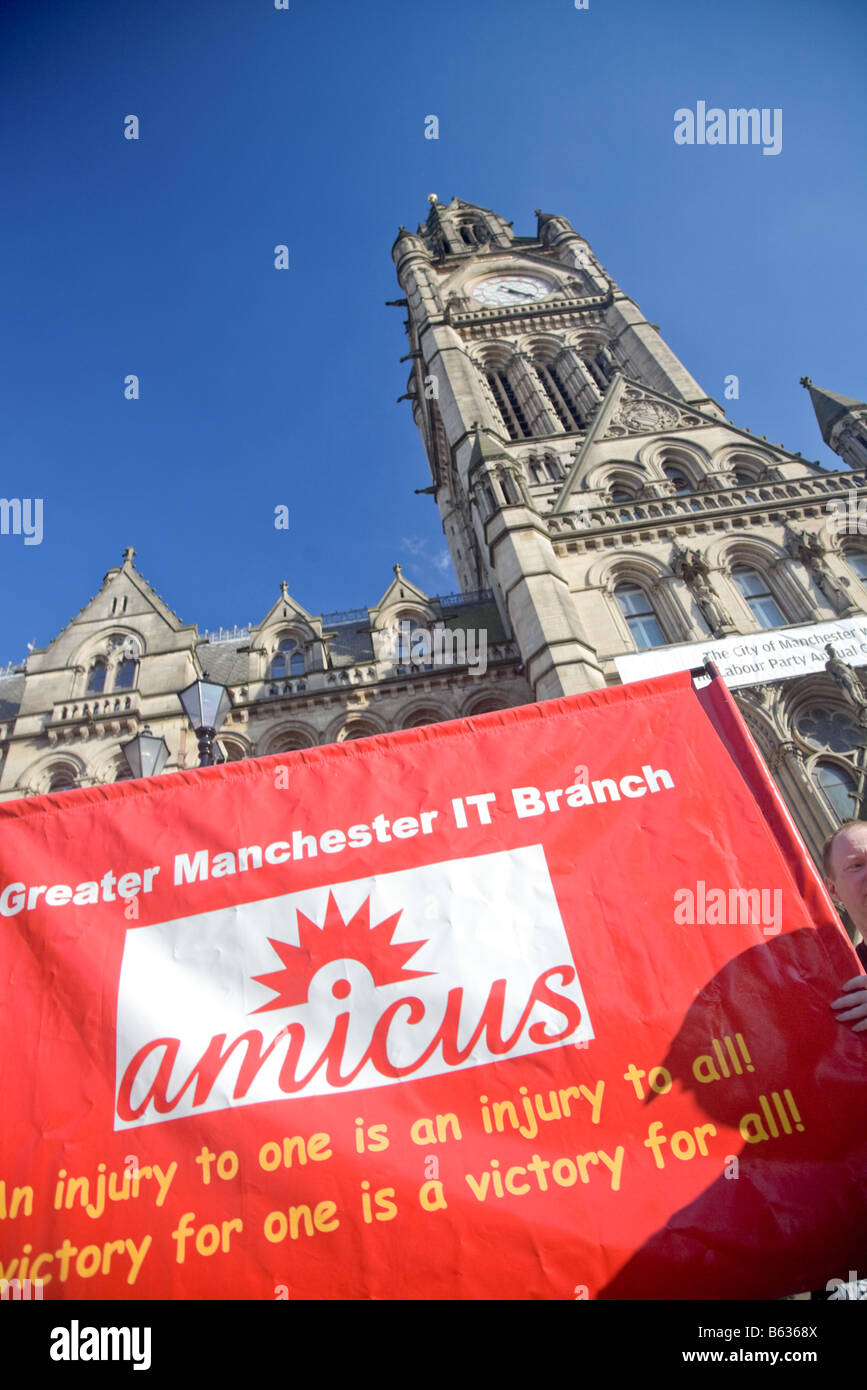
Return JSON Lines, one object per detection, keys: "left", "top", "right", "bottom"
{"left": 115, "top": 845, "right": 593, "bottom": 1129}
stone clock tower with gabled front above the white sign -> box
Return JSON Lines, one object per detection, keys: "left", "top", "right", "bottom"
{"left": 392, "top": 195, "right": 839, "bottom": 699}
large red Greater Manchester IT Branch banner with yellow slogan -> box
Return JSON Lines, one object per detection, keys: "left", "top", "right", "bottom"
{"left": 0, "top": 673, "right": 867, "bottom": 1300}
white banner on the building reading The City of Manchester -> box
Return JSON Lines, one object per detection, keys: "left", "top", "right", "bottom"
{"left": 614, "top": 614, "right": 867, "bottom": 689}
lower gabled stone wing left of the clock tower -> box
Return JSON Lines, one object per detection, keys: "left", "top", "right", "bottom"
{"left": 0, "top": 549, "right": 532, "bottom": 801}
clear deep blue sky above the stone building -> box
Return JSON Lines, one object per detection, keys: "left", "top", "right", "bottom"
{"left": 0, "top": 0, "right": 867, "bottom": 663}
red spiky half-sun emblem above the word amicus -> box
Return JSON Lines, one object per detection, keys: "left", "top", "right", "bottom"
{"left": 251, "top": 892, "right": 435, "bottom": 1013}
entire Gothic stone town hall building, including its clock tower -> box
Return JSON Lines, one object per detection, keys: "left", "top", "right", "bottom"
{"left": 0, "top": 197, "right": 867, "bottom": 872}
